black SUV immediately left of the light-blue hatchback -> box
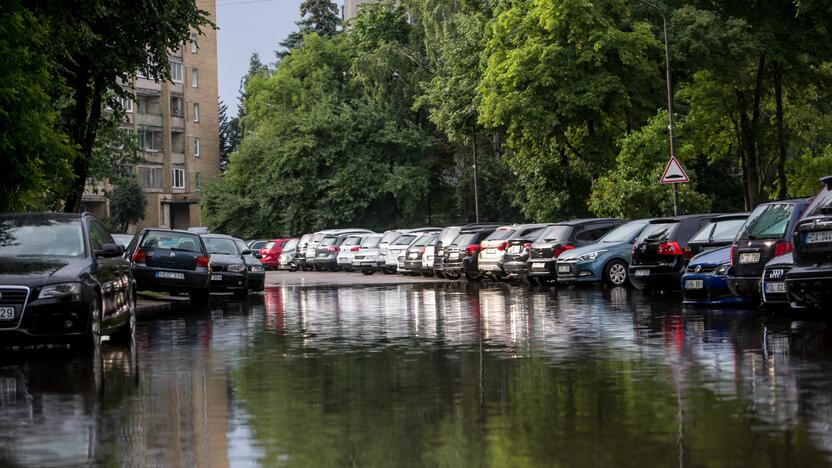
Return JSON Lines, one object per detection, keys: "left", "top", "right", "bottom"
{"left": 526, "top": 218, "right": 625, "bottom": 283}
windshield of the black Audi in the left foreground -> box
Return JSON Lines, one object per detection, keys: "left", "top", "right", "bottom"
{"left": 0, "top": 218, "right": 86, "bottom": 257}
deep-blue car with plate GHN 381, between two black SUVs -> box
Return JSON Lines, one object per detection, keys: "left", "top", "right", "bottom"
{"left": 682, "top": 247, "right": 749, "bottom": 305}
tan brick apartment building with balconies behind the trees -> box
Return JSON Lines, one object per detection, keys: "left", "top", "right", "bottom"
{"left": 82, "top": 0, "right": 220, "bottom": 230}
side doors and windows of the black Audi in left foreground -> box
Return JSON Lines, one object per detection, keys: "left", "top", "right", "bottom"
{"left": 87, "top": 218, "right": 130, "bottom": 330}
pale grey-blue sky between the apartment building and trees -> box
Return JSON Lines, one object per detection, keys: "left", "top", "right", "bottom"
{"left": 217, "top": 0, "right": 308, "bottom": 116}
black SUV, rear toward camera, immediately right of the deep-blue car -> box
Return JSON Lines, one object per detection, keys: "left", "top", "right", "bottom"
{"left": 728, "top": 198, "right": 807, "bottom": 301}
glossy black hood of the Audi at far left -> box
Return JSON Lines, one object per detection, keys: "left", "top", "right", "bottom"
{"left": 0, "top": 257, "right": 89, "bottom": 286}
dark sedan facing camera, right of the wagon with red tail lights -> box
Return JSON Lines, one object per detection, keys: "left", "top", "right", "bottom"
{"left": 201, "top": 234, "right": 248, "bottom": 298}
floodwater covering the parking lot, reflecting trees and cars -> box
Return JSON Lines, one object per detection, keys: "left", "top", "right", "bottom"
{"left": 0, "top": 282, "right": 832, "bottom": 467}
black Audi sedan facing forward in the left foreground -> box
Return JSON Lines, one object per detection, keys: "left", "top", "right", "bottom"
{"left": 0, "top": 213, "right": 136, "bottom": 347}
